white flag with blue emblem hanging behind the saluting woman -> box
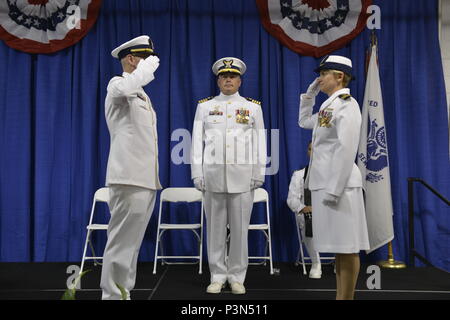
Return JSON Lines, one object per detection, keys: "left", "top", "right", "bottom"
{"left": 357, "top": 44, "right": 394, "bottom": 253}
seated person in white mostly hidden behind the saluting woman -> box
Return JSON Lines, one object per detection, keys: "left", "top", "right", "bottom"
{"left": 286, "top": 142, "right": 322, "bottom": 279}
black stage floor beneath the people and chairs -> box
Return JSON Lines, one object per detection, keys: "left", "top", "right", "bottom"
{"left": 0, "top": 262, "right": 450, "bottom": 302}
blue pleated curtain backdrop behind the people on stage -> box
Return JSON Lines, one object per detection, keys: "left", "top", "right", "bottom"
{"left": 0, "top": 0, "right": 450, "bottom": 271}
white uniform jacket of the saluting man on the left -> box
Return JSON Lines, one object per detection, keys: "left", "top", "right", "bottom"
{"left": 105, "top": 60, "right": 161, "bottom": 190}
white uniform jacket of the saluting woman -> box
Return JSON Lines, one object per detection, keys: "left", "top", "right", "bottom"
{"left": 299, "top": 88, "right": 362, "bottom": 197}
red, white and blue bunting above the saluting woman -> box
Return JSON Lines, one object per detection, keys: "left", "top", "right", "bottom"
{"left": 256, "top": 0, "right": 372, "bottom": 57}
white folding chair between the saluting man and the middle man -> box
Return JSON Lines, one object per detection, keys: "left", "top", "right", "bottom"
{"left": 153, "top": 188, "right": 203, "bottom": 274}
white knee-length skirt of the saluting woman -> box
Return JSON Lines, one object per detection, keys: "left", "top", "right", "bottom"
{"left": 311, "top": 188, "right": 369, "bottom": 253}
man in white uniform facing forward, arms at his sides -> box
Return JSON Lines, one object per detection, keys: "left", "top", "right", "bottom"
{"left": 191, "top": 57, "right": 266, "bottom": 294}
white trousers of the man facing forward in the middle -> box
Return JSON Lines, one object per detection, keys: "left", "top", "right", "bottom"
{"left": 204, "top": 191, "right": 254, "bottom": 284}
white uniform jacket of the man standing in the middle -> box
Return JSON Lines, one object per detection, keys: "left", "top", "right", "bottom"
{"left": 191, "top": 92, "right": 266, "bottom": 193}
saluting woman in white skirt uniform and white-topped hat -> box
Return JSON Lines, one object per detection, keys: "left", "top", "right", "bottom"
{"left": 299, "top": 56, "right": 369, "bottom": 300}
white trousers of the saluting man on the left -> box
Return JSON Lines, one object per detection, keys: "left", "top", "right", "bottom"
{"left": 100, "top": 185, "right": 156, "bottom": 300}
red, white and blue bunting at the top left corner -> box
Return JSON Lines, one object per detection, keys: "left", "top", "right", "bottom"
{"left": 0, "top": 0, "right": 102, "bottom": 53}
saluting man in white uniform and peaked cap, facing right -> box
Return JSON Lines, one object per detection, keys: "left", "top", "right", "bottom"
{"left": 100, "top": 36, "right": 161, "bottom": 300}
